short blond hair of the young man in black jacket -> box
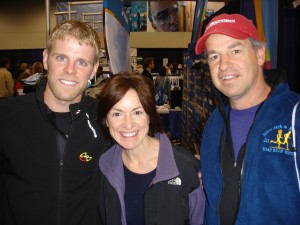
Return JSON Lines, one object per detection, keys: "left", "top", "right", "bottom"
{"left": 47, "top": 20, "right": 100, "bottom": 62}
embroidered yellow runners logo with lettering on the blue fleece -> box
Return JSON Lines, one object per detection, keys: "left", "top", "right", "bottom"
{"left": 262, "top": 124, "right": 293, "bottom": 155}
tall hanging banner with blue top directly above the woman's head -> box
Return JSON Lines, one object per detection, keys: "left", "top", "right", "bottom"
{"left": 103, "top": 0, "right": 131, "bottom": 74}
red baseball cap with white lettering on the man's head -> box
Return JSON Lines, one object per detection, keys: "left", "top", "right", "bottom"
{"left": 195, "top": 14, "right": 259, "bottom": 54}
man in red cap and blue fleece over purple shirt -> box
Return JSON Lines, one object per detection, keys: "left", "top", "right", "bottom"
{"left": 195, "top": 14, "right": 300, "bottom": 225}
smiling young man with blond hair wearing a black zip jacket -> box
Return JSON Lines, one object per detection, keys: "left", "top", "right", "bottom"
{"left": 0, "top": 21, "right": 108, "bottom": 225}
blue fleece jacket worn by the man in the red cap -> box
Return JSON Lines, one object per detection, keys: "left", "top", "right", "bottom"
{"left": 200, "top": 83, "right": 300, "bottom": 225}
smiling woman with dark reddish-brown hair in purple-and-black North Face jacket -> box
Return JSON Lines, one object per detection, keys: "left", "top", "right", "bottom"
{"left": 99, "top": 74, "right": 205, "bottom": 225}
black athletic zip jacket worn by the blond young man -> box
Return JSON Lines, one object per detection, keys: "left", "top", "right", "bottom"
{"left": 0, "top": 81, "right": 108, "bottom": 225}
